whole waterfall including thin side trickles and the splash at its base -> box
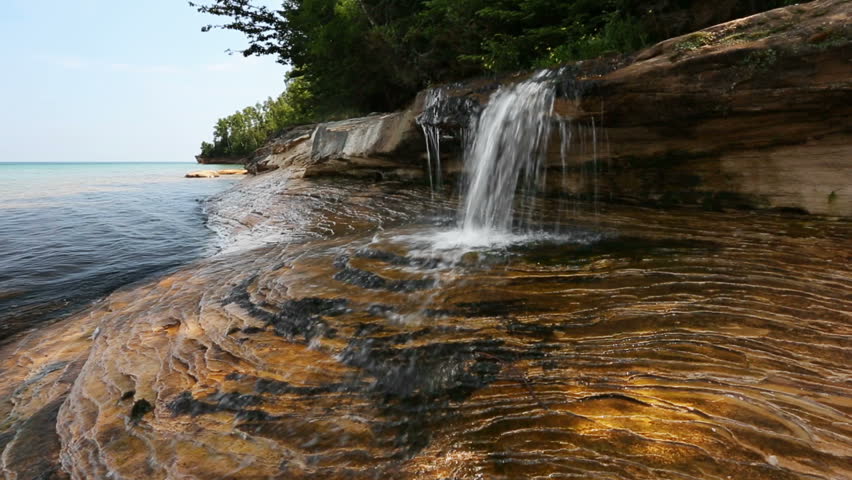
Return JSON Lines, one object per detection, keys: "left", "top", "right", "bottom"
{"left": 417, "top": 69, "right": 605, "bottom": 248}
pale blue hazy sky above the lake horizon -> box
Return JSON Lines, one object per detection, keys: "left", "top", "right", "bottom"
{"left": 0, "top": 0, "right": 285, "bottom": 162}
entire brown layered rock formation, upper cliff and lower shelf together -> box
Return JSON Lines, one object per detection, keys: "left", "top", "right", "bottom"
{"left": 0, "top": 0, "right": 852, "bottom": 480}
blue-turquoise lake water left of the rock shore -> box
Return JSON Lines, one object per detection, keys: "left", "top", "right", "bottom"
{"left": 0, "top": 163, "right": 239, "bottom": 341}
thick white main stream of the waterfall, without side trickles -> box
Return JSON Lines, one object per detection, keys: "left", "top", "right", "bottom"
{"left": 459, "top": 71, "right": 555, "bottom": 235}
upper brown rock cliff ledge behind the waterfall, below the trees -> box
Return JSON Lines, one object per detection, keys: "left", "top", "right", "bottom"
{"left": 248, "top": 0, "right": 852, "bottom": 216}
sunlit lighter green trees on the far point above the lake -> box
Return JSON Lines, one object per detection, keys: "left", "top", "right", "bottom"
{"left": 201, "top": 79, "right": 314, "bottom": 158}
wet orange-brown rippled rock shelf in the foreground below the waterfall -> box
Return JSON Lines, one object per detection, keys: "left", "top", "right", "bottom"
{"left": 0, "top": 177, "right": 852, "bottom": 480}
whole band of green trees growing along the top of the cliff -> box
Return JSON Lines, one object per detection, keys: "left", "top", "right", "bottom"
{"left": 196, "top": 0, "right": 794, "bottom": 155}
